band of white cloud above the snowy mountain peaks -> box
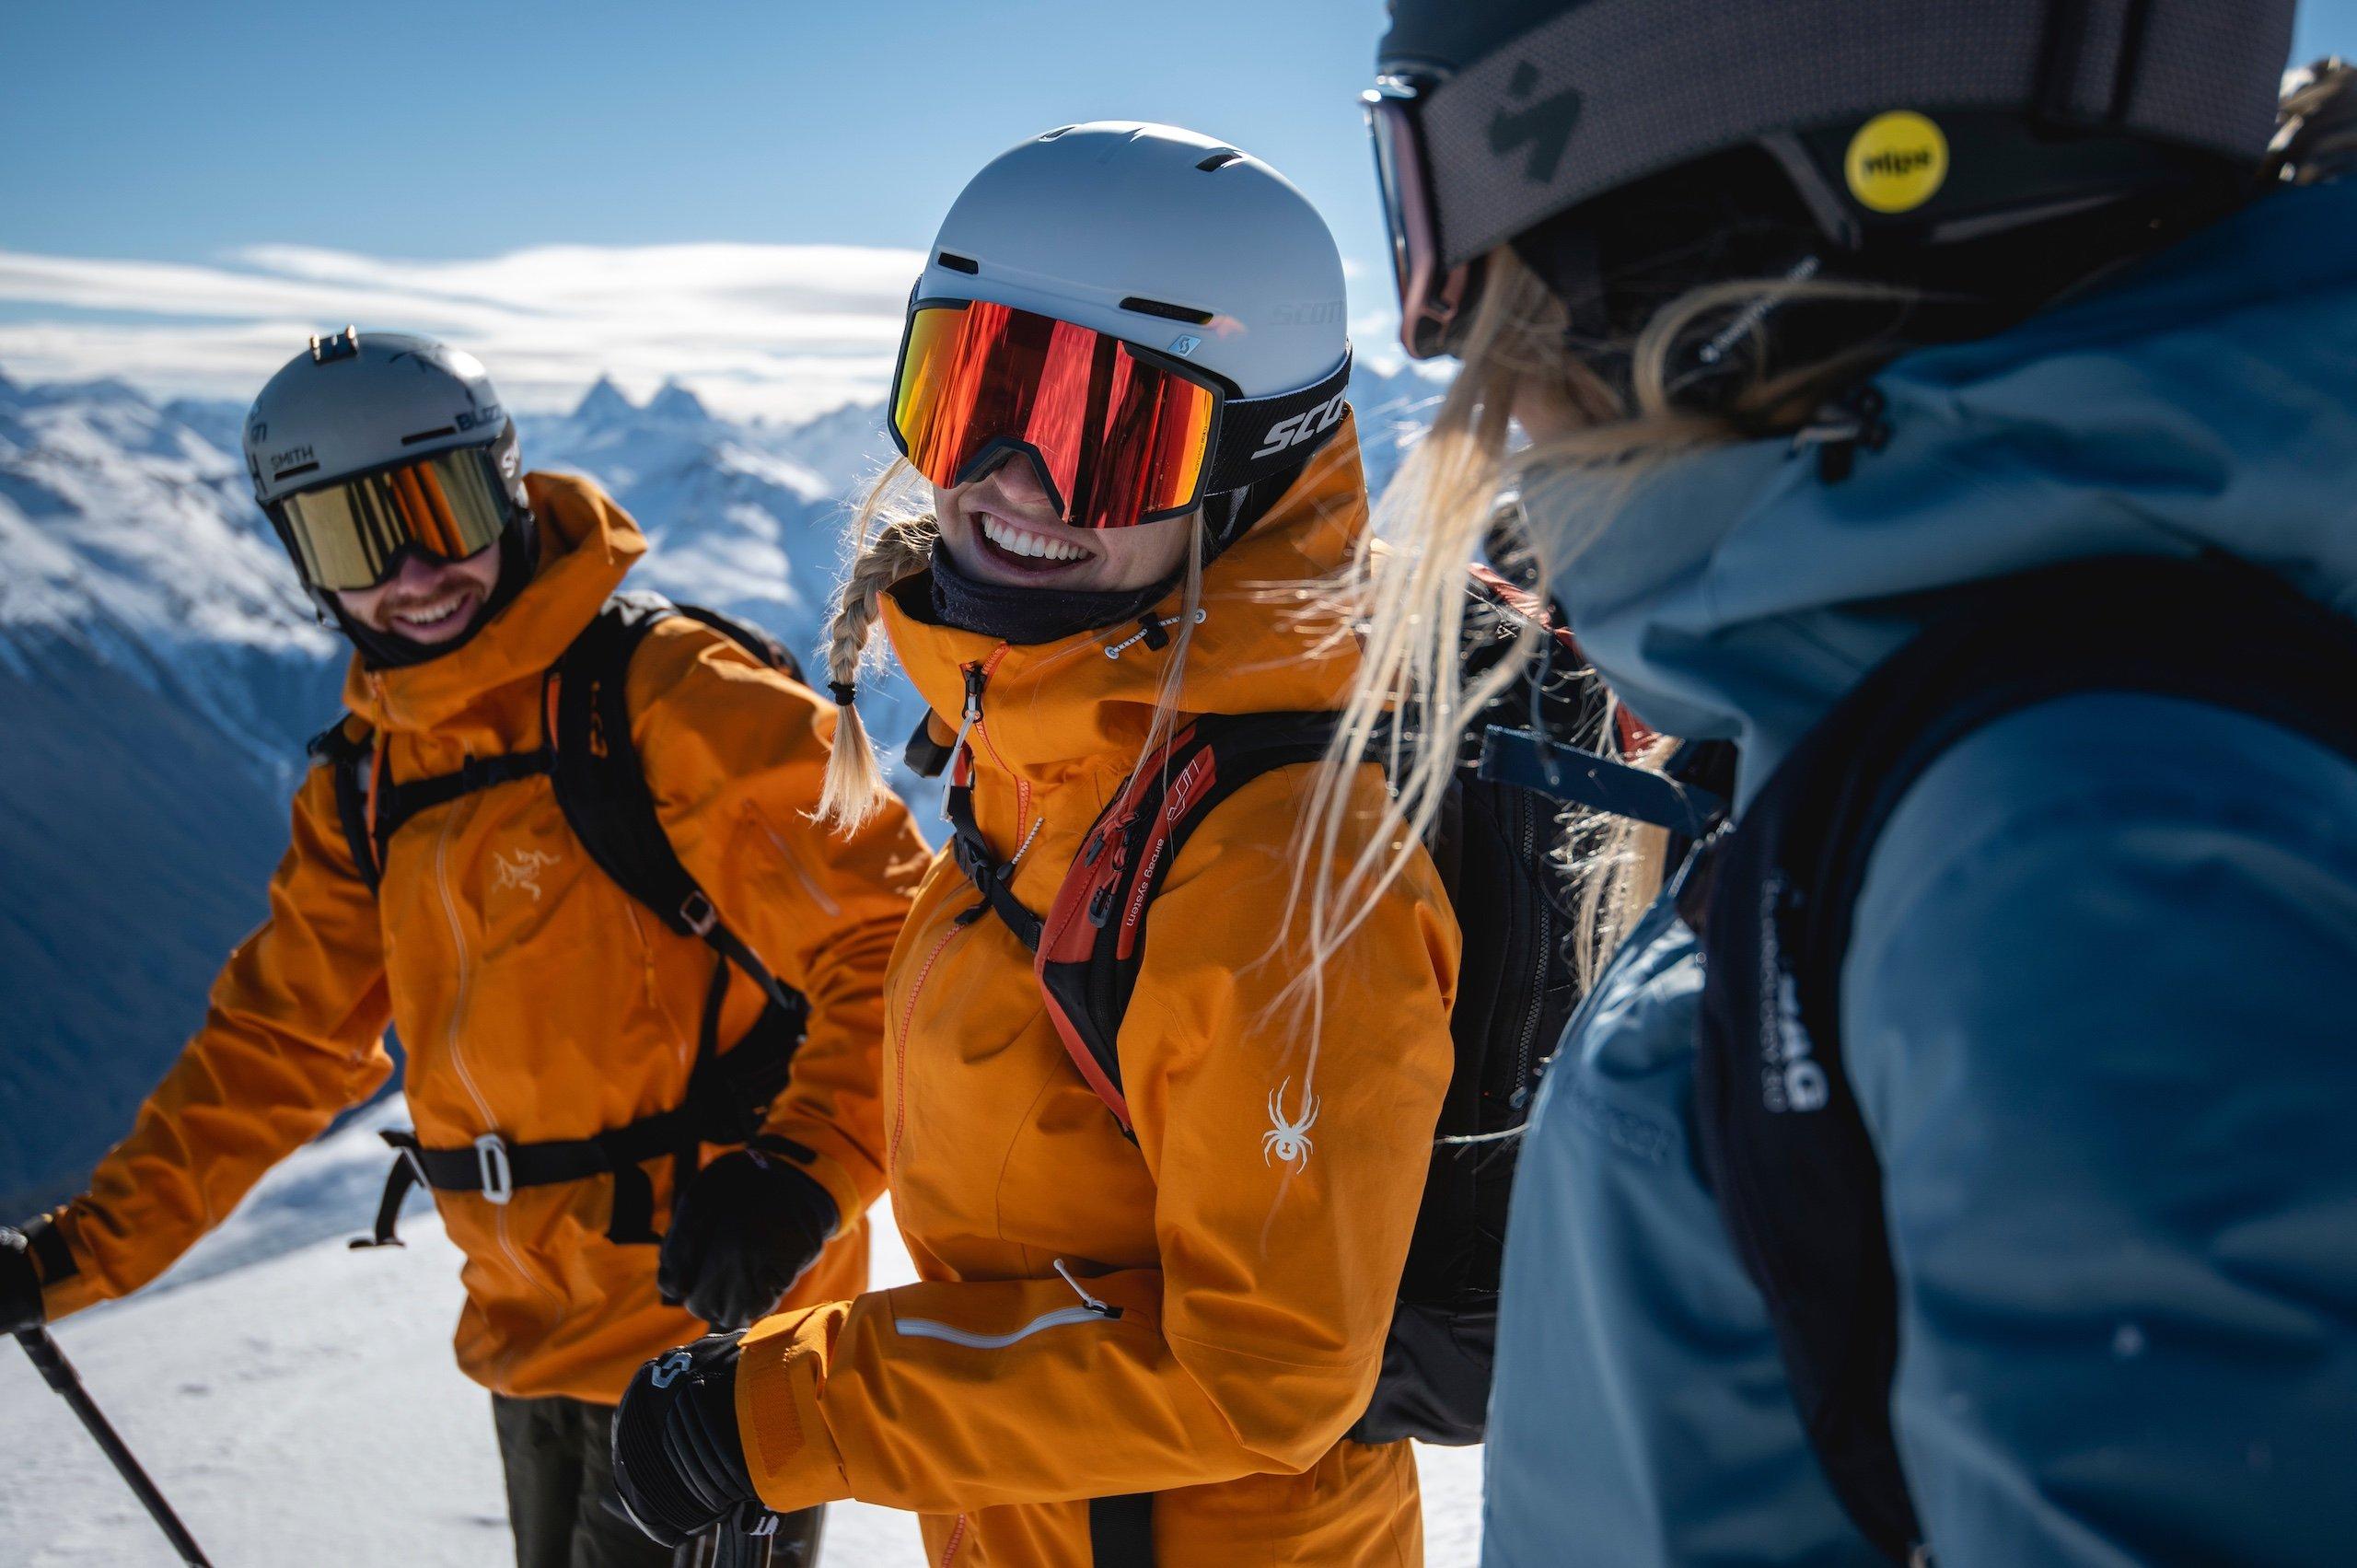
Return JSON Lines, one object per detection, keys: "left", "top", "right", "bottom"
{"left": 0, "top": 245, "right": 924, "bottom": 420}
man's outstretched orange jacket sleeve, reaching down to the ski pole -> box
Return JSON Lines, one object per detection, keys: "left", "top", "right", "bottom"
{"left": 42, "top": 769, "right": 394, "bottom": 1318}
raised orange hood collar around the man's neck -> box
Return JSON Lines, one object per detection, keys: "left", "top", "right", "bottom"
{"left": 344, "top": 474, "right": 645, "bottom": 738}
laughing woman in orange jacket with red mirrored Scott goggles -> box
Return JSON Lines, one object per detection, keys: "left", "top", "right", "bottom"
{"left": 615, "top": 125, "right": 1459, "bottom": 1568}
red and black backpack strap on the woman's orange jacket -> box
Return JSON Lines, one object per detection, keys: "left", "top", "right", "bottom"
{"left": 1032, "top": 712, "right": 1334, "bottom": 1139}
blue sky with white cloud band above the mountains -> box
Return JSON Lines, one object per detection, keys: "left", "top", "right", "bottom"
{"left": 0, "top": 0, "right": 2357, "bottom": 412}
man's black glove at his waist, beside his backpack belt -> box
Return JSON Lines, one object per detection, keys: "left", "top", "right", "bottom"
{"left": 656, "top": 1148, "right": 839, "bottom": 1330}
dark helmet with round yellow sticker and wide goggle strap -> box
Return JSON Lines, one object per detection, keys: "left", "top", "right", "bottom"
{"left": 1376, "top": 0, "right": 2293, "bottom": 352}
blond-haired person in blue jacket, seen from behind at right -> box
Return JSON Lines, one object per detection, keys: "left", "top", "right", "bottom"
{"left": 1353, "top": 0, "right": 2357, "bottom": 1568}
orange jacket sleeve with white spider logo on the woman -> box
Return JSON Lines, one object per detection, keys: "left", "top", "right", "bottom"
{"left": 737, "top": 769, "right": 1459, "bottom": 1512}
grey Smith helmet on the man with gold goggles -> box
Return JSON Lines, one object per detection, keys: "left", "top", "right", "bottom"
{"left": 245, "top": 328, "right": 526, "bottom": 509}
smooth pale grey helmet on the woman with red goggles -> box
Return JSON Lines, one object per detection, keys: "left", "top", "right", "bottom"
{"left": 914, "top": 121, "right": 1351, "bottom": 399}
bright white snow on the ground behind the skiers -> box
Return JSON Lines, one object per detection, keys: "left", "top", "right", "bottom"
{"left": 0, "top": 1106, "right": 1480, "bottom": 1568}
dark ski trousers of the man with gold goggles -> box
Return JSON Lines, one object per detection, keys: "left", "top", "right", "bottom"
{"left": 490, "top": 1393, "right": 825, "bottom": 1568}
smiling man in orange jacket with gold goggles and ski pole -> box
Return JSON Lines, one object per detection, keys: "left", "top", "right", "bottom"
{"left": 0, "top": 332, "right": 926, "bottom": 1568}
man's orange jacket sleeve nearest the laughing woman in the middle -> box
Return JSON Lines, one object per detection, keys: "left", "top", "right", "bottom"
{"left": 632, "top": 622, "right": 929, "bottom": 1224}
